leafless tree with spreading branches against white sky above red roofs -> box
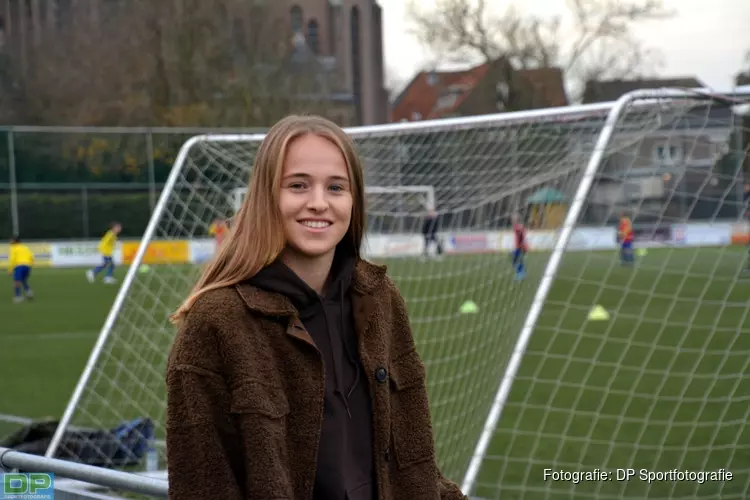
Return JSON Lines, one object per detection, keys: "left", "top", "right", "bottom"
{"left": 409, "top": 0, "right": 673, "bottom": 102}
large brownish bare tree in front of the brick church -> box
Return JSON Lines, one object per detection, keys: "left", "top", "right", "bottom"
{"left": 16, "top": 0, "right": 340, "bottom": 127}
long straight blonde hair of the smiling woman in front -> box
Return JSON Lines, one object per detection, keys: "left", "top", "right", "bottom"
{"left": 169, "top": 115, "right": 366, "bottom": 324}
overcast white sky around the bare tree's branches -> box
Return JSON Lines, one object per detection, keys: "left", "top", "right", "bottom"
{"left": 378, "top": 0, "right": 750, "bottom": 94}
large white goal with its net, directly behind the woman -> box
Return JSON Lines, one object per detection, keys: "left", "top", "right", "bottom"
{"left": 48, "top": 90, "right": 750, "bottom": 499}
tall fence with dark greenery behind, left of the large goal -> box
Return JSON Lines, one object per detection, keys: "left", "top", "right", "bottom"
{"left": 0, "top": 126, "right": 264, "bottom": 240}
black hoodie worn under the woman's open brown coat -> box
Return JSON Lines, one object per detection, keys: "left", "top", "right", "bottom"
{"left": 250, "top": 246, "right": 377, "bottom": 500}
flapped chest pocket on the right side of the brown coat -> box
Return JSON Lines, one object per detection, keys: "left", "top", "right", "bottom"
{"left": 390, "top": 350, "right": 435, "bottom": 469}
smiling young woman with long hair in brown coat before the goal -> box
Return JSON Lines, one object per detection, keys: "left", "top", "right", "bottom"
{"left": 167, "top": 116, "right": 466, "bottom": 500}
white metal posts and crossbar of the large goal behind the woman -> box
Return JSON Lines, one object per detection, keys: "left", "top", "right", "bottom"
{"left": 45, "top": 88, "right": 736, "bottom": 495}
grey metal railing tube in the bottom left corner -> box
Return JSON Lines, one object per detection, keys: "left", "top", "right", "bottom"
{"left": 0, "top": 447, "right": 168, "bottom": 498}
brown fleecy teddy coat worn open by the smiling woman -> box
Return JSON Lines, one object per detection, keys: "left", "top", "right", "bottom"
{"left": 167, "top": 260, "right": 467, "bottom": 500}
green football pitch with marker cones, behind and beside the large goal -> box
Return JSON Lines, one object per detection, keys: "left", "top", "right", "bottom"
{"left": 0, "top": 248, "right": 750, "bottom": 499}
